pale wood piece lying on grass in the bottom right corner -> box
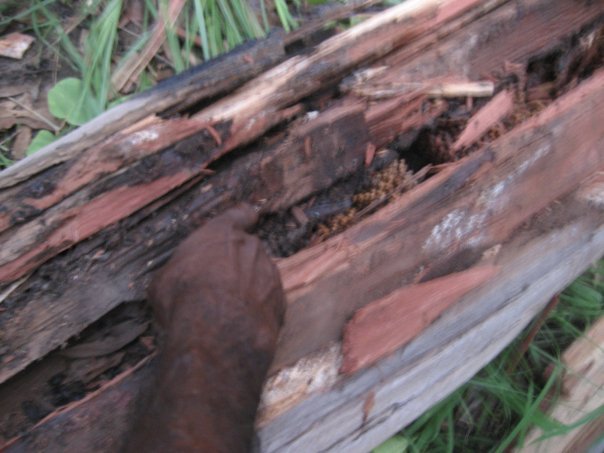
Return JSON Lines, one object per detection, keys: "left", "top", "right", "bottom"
{"left": 517, "top": 318, "right": 604, "bottom": 453}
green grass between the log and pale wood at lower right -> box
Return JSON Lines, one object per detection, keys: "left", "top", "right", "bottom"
{"left": 375, "top": 259, "right": 604, "bottom": 453}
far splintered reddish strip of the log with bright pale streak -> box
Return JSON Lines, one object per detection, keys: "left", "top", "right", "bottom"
{"left": 0, "top": 0, "right": 500, "bottom": 283}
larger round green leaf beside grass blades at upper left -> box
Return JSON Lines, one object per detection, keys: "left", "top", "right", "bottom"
{"left": 48, "top": 77, "right": 101, "bottom": 126}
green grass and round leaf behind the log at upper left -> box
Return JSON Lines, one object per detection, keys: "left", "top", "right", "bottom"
{"left": 0, "top": 0, "right": 299, "bottom": 162}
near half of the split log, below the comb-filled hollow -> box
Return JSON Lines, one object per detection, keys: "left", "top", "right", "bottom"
{"left": 4, "top": 67, "right": 604, "bottom": 451}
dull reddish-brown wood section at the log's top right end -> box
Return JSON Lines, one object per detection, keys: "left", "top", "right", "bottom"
{"left": 378, "top": 0, "right": 604, "bottom": 81}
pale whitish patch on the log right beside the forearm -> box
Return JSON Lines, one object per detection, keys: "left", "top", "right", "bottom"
{"left": 257, "top": 344, "right": 342, "bottom": 425}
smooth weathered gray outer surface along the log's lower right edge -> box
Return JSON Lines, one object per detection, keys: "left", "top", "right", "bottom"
{"left": 259, "top": 199, "right": 604, "bottom": 452}
